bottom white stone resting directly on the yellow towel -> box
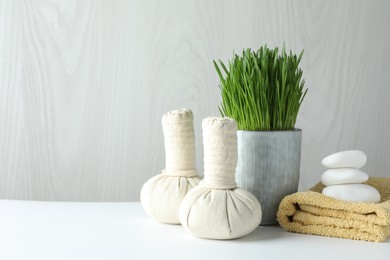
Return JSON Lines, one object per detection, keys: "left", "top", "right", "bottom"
{"left": 322, "top": 184, "right": 381, "bottom": 202}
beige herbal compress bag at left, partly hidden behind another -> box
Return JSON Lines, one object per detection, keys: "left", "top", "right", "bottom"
{"left": 141, "top": 109, "right": 201, "bottom": 224}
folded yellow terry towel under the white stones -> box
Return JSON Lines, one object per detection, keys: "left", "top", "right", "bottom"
{"left": 277, "top": 177, "right": 390, "bottom": 242}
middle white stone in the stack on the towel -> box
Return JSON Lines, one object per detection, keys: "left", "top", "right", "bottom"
{"left": 321, "top": 168, "right": 368, "bottom": 186}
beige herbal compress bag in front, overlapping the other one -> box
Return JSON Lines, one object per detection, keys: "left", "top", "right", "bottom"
{"left": 179, "top": 117, "right": 261, "bottom": 239}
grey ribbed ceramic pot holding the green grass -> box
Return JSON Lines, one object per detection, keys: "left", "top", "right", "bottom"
{"left": 236, "top": 129, "right": 302, "bottom": 225}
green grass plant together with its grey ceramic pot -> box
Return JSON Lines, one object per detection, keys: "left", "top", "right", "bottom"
{"left": 214, "top": 45, "right": 307, "bottom": 225}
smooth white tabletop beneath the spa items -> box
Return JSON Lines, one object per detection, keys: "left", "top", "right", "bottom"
{"left": 0, "top": 200, "right": 390, "bottom": 260}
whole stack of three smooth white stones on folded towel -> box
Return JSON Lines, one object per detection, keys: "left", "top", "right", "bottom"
{"left": 321, "top": 150, "right": 381, "bottom": 202}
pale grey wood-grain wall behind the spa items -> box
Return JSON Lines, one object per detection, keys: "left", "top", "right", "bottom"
{"left": 0, "top": 0, "right": 390, "bottom": 201}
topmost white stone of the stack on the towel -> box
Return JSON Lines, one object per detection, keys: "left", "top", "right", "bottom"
{"left": 321, "top": 150, "right": 367, "bottom": 169}
